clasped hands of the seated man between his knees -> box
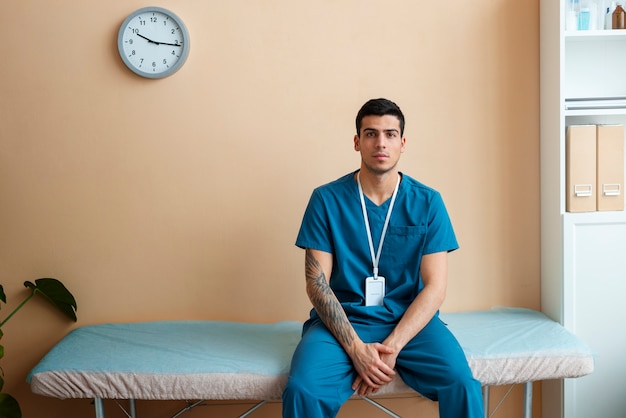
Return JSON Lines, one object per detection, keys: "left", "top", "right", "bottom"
{"left": 352, "top": 343, "right": 398, "bottom": 396}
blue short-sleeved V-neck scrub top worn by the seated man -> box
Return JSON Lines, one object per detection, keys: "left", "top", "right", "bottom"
{"left": 296, "top": 172, "right": 459, "bottom": 324}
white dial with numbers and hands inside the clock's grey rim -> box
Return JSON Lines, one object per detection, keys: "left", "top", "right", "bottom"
{"left": 123, "top": 11, "right": 185, "bottom": 74}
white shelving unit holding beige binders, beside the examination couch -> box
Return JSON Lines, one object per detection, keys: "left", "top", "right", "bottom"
{"left": 540, "top": 0, "right": 626, "bottom": 418}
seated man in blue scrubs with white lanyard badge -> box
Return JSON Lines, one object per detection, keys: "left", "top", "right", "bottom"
{"left": 283, "top": 99, "right": 483, "bottom": 418}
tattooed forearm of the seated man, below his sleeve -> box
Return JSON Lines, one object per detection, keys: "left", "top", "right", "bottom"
{"left": 305, "top": 251, "right": 354, "bottom": 347}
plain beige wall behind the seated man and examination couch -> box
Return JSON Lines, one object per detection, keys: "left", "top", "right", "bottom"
{"left": 0, "top": 0, "right": 540, "bottom": 418}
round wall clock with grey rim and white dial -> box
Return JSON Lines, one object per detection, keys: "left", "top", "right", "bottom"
{"left": 117, "top": 7, "right": 189, "bottom": 78}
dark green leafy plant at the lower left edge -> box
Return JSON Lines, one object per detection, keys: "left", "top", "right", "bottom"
{"left": 0, "top": 278, "right": 76, "bottom": 418}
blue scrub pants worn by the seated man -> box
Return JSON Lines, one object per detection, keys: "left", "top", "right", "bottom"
{"left": 283, "top": 316, "right": 484, "bottom": 418}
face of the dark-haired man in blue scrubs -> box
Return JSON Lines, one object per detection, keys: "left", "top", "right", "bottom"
{"left": 354, "top": 115, "right": 406, "bottom": 174}
